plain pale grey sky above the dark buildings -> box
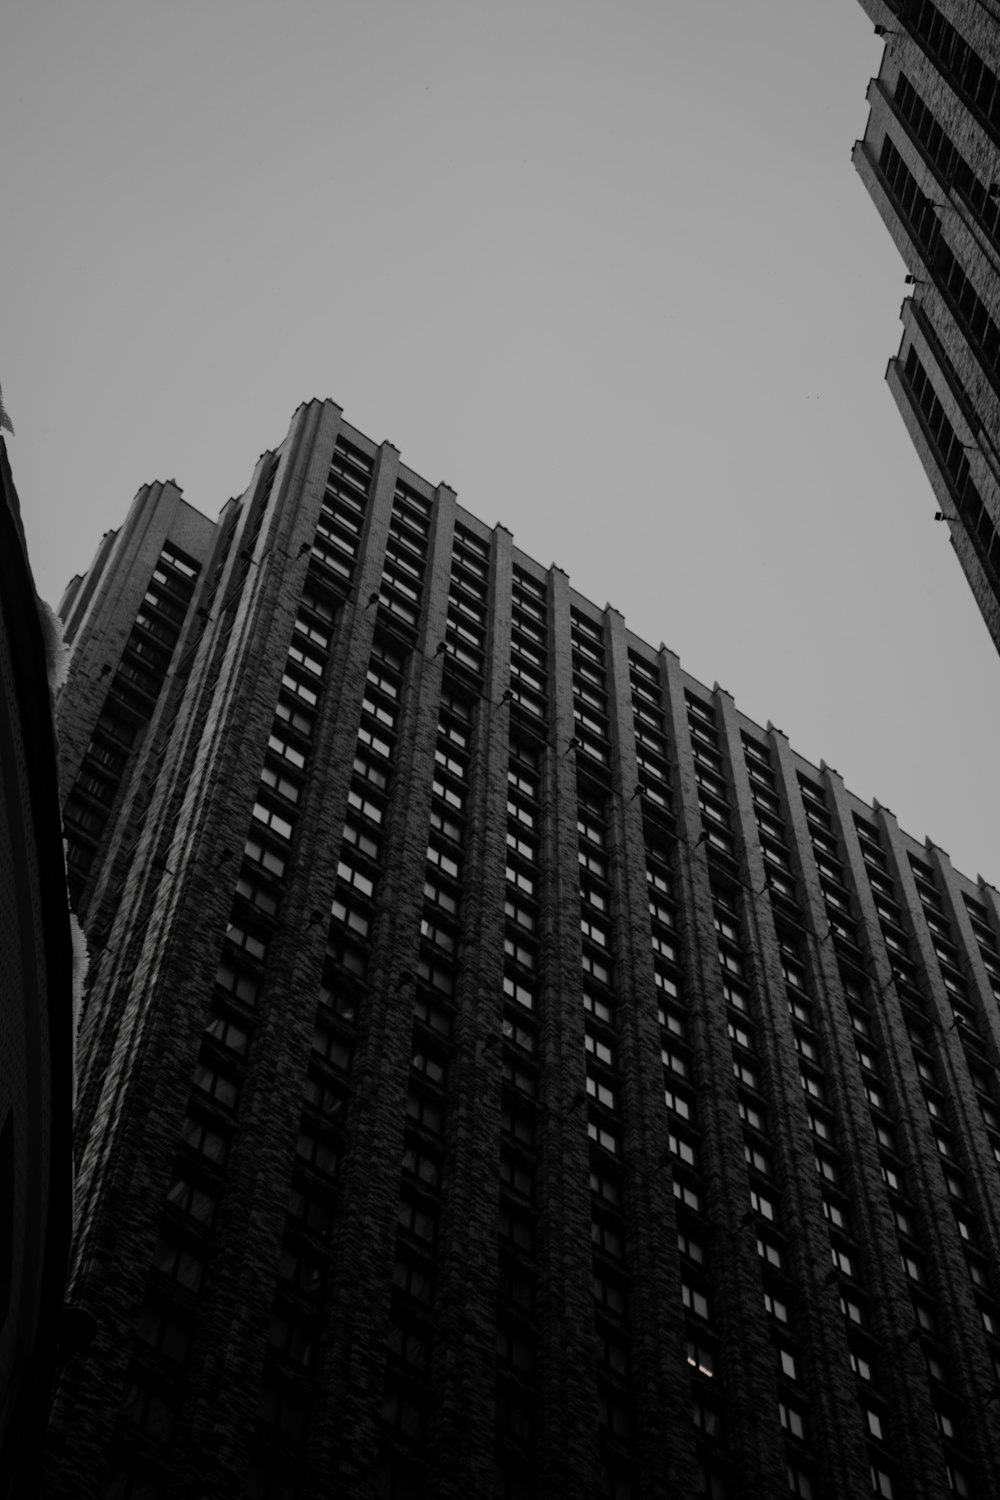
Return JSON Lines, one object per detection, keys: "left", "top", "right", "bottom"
{"left": 0, "top": 0, "right": 1000, "bottom": 884}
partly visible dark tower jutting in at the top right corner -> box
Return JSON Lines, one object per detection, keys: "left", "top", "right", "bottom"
{"left": 855, "top": 0, "right": 1000, "bottom": 650}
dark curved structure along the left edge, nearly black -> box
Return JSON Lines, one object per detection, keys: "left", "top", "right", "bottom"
{"left": 0, "top": 440, "right": 73, "bottom": 1500}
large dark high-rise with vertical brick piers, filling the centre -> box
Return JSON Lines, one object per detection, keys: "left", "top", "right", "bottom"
{"left": 43, "top": 402, "right": 1000, "bottom": 1500}
